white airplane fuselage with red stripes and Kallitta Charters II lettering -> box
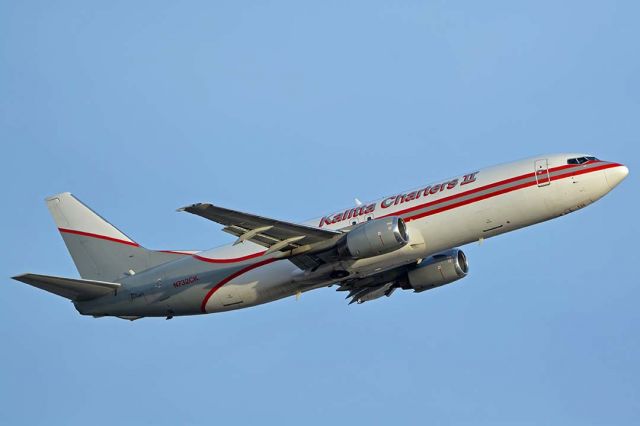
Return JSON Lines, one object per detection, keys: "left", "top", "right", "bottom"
{"left": 76, "top": 154, "right": 627, "bottom": 316}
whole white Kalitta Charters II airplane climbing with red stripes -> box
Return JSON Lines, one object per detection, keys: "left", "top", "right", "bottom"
{"left": 13, "top": 154, "right": 629, "bottom": 321}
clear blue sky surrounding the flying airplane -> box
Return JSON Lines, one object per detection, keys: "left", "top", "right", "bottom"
{"left": 0, "top": 0, "right": 640, "bottom": 425}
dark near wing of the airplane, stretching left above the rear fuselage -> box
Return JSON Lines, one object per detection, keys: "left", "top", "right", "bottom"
{"left": 178, "top": 203, "right": 344, "bottom": 269}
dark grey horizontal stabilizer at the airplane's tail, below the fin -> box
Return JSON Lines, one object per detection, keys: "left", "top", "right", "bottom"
{"left": 13, "top": 274, "right": 120, "bottom": 302}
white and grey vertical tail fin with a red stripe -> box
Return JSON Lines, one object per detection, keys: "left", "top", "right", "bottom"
{"left": 46, "top": 192, "right": 176, "bottom": 282}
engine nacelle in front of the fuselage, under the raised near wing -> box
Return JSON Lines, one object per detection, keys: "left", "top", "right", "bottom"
{"left": 338, "top": 216, "right": 409, "bottom": 259}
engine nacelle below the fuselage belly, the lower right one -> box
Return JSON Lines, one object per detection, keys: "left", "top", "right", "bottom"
{"left": 407, "top": 249, "right": 469, "bottom": 292}
